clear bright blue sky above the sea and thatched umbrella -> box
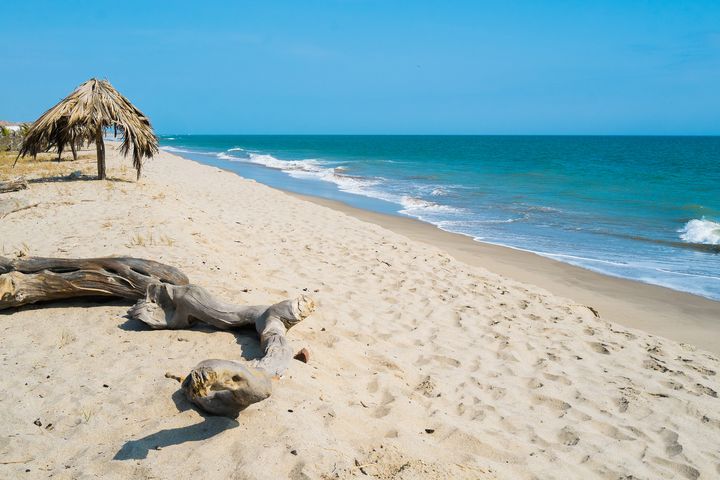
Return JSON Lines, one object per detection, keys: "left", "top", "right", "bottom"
{"left": 0, "top": 0, "right": 720, "bottom": 135}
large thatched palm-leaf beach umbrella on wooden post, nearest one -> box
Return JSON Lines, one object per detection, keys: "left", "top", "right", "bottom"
{"left": 18, "top": 78, "right": 158, "bottom": 180}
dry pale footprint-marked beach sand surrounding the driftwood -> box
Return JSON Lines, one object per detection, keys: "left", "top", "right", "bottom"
{"left": 0, "top": 147, "right": 720, "bottom": 479}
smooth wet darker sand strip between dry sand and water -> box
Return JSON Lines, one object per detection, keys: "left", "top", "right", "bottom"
{"left": 286, "top": 191, "right": 720, "bottom": 354}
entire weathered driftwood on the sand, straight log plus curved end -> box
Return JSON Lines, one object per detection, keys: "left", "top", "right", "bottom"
{"left": 0, "top": 257, "right": 315, "bottom": 417}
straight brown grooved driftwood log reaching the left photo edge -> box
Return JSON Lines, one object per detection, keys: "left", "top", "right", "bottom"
{"left": 0, "top": 257, "right": 188, "bottom": 310}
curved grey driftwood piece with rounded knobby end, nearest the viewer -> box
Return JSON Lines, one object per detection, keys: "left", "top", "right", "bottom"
{"left": 128, "top": 283, "right": 315, "bottom": 418}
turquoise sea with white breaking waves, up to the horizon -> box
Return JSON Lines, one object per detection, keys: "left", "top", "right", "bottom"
{"left": 160, "top": 135, "right": 720, "bottom": 300}
